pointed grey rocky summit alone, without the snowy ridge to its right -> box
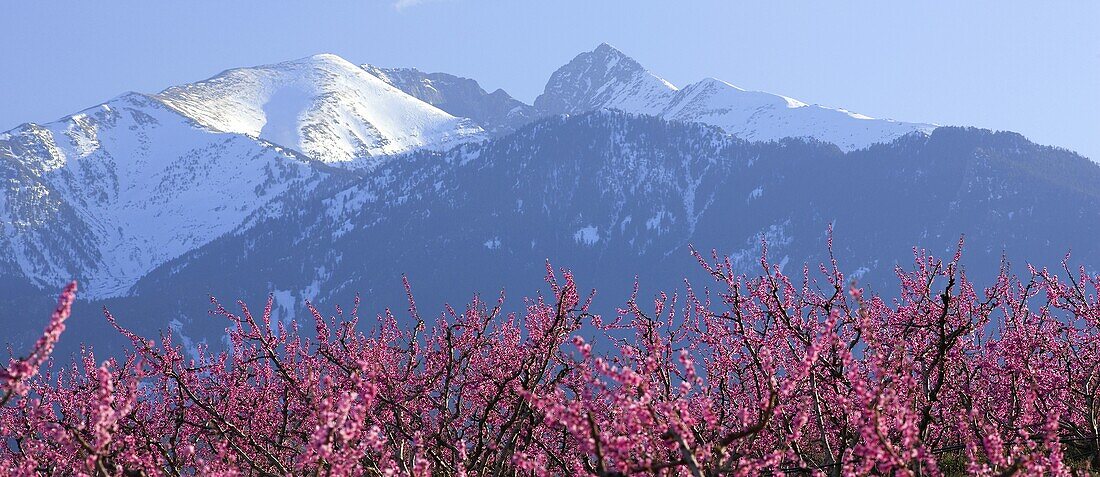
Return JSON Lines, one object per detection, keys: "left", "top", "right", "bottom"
{"left": 535, "top": 43, "right": 677, "bottom": 114}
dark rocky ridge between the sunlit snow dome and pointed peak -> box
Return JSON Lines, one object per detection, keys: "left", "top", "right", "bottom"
{"left": 363, "top": 65, "right": 538, "bottom": 136}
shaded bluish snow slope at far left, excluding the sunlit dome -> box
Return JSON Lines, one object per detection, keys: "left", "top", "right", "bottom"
{"left": 0, "top": 93, "right": 327, "bottom": 297}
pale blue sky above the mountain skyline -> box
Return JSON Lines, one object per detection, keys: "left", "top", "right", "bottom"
{"left": 0, "top": 0, "right": 1100, "bottom": 159}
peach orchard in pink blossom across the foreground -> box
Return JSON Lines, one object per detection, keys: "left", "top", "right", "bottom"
{"left": 0, "top": 243, "right": 1100, "bottom": 476}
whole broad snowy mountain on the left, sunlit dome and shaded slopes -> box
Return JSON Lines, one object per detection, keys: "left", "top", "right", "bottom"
{"left": 0, "top": 55, "right": 486, "bottom": 298}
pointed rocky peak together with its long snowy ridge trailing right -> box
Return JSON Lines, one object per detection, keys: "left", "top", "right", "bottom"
{"left": 535, "top": 44, "right": 936, "bottom": 151}
